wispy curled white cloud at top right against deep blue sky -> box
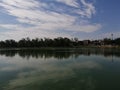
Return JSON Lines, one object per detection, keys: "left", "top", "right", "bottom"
{"left": 56, "top": 0, "right": 96, "bottom": 18}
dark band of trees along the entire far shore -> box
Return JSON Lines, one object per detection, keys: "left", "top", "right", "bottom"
{"left": 0, "top": 37, "right": 120, "bottom": 48}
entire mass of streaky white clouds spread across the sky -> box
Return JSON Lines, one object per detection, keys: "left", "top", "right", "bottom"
{"left": 0, "top": 0, "right": 101, "bottom": 38}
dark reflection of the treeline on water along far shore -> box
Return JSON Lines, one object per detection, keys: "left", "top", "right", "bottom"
{"left": 0, "top": 48, "right": 120, "bottom": 59}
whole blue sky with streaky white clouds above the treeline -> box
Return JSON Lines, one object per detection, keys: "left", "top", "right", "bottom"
{"left": 0, "top": 0, "right": 120, "bottom": 40}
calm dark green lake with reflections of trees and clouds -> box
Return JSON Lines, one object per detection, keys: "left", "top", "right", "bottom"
{"left": 0, "top": 48, "right": 120, "bottom": 90}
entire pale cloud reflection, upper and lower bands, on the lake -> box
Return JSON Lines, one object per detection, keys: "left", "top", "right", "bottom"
{"left": 2, "top": 57, "right": 100, "bottom": 90}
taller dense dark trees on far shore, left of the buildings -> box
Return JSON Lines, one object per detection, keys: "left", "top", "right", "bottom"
{"left": 0, "top": 37, "right": 78, "bottom": 48}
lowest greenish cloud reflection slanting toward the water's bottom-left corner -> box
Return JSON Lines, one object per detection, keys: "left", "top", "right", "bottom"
{"left": 3, "top": 71, "right": 72, "bottom": 90}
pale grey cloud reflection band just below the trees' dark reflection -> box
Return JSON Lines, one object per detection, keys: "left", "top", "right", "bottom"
{"left": 0, "top": 55, "right": 100, "bottom": 72}
